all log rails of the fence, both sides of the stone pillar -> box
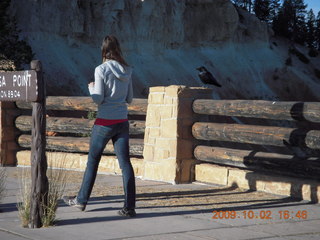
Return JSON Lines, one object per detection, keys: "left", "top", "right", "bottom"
{"left": 11, "top": 94, "right": 320, "bottom": 184}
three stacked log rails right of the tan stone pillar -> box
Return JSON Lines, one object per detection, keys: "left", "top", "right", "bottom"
{"left": 192, "top": 99, "right": 320, "bottom": 180}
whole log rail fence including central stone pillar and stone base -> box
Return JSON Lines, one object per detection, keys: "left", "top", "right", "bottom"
{"left": 3, "top": 86, "right": 320, "bottom": 202}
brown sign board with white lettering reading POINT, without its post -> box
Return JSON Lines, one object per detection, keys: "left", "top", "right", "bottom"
{"left": 0, "top": 70, "right": 39, "bottom": 102}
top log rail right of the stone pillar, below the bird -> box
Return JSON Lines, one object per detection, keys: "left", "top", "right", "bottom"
{"left": 192, "top": 99, "right": 320, "bottom": 123}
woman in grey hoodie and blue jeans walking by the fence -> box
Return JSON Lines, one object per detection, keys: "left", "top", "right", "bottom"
{"left": 63, "top": 36, "right": 136, "bottom": 217}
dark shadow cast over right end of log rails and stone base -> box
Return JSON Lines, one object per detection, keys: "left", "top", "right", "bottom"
{"left": 244, "top": 102, "right": 320, "bottom": 203}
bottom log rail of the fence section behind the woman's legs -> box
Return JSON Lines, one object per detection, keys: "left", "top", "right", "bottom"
{"left": 18, "top": 135, "right": 143, "bottom": 156}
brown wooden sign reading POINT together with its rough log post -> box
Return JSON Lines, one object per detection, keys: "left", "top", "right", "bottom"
{"left": 0, "top": 60, "right": 49, "bottom": 228}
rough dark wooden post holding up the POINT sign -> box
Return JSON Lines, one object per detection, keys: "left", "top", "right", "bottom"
{"left": 30, "top": 60, "right": 49, "bottom": 228}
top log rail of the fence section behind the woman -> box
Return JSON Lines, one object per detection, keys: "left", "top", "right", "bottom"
{"left": 16, "top": 96, "right": 148, "bottom": 115}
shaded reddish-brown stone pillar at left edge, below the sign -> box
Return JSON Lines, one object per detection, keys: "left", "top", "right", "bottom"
{"left": 0, "top": 102, "right": 18, "bottom": 166}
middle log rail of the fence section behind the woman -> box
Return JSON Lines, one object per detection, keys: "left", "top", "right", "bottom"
{"left": 15, "top": 115, "right": 145, "bottom": 135}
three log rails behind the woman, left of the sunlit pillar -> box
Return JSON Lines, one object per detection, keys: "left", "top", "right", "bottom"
{"left": 15, "top": 96, "right": 147, "bottom": 157}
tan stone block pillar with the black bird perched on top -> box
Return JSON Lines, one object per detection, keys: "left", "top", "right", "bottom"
{"left": 143, "top": 86, "right": 212, "bottom": 183}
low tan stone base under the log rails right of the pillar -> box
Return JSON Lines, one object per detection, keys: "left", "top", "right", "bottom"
{"left": 195, "top": 163, "right": 320, "bottom": 203}
